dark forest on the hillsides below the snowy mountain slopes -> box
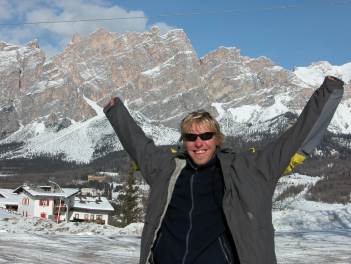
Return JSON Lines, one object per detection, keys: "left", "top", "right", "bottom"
{"left": 0, "top": 132, "right": 351, "bottom": 203}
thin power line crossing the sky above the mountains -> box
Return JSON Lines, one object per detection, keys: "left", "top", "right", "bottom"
{"left": 0, "top": 0, "right": 351, "bottom": 26}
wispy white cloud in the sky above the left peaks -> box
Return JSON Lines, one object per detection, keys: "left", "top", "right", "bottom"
{"left": 0, "top": 0, "right": 172, "bottom": 56}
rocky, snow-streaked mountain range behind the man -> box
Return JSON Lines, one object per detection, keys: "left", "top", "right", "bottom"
{"left": 0, "top": 27, "right": 351, "bottom": 162}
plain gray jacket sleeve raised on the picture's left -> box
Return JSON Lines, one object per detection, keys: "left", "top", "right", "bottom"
{"left": 104, "top": 98, "right": 172, "bottom": 185}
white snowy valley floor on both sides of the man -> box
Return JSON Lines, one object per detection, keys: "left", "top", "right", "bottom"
{"left": 0, "top": 174, "right": 351, "bottom": 264}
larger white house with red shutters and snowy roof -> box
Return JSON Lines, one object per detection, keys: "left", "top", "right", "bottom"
{"left": 14, "top": 185, "right": 79, "bottom": 222}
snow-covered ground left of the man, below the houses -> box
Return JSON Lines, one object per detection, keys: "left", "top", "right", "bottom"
{"left": 0, "top": 209, "right": 143, "bottom": 264}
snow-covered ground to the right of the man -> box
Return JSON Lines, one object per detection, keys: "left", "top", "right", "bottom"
{"left": 273, "top": 199, "right": 351, "bottom": 264}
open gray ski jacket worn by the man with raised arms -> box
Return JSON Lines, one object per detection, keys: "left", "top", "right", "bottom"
{"left": 104, "top": 75, "right": 344, "bottom": 264}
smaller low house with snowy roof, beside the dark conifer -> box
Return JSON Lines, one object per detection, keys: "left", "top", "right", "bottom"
{"left": 70, "top": 195, "right": 114, "bottom": 225}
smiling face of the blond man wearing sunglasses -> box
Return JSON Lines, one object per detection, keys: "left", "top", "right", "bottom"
{"left": 183, "top": 123, "right": 219, "bottom": 165}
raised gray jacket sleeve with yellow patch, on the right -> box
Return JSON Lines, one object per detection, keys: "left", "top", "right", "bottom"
{"left": 256, "top": 78, "right": 344, "bottom": 181}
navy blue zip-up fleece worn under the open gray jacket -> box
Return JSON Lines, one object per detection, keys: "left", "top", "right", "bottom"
{"left": 154, "top": 157, "right": 230, "bottom": 264}
